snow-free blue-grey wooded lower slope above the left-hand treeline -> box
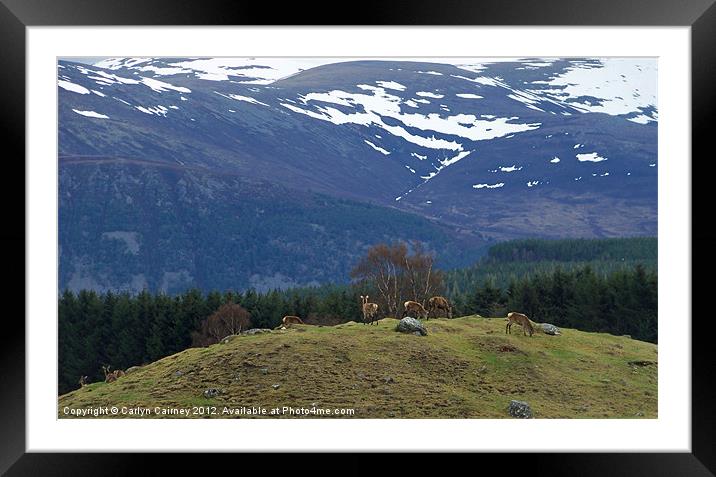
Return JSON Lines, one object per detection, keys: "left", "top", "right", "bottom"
{"left": 59, "top": 157, "right": 485, "bottom": 293}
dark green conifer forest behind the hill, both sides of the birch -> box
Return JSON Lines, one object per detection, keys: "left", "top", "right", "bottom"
{"left": 58, "top": 235, "right": 657, "bottom": 394}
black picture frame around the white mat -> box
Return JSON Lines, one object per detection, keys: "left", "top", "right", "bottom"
{"left": 0, "top": 0, "right": 716, "bottom": 476}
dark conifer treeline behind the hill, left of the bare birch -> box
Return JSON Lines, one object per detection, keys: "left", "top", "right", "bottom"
{"left": 58, "top": 286, "right": 361, "bottom": 394}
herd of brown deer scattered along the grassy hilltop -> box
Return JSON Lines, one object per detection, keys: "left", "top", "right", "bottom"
{"left": 79, "top": 295, "right": 535, "bottom": 387}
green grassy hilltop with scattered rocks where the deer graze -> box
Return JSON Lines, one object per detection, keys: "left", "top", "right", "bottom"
{"left": 58, "top": 316, "right": 657, "bottom": 419}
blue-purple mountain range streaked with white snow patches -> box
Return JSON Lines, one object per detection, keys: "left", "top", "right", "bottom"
{"left": 58, "top": 58, "right": 658, "bottom": 292}
